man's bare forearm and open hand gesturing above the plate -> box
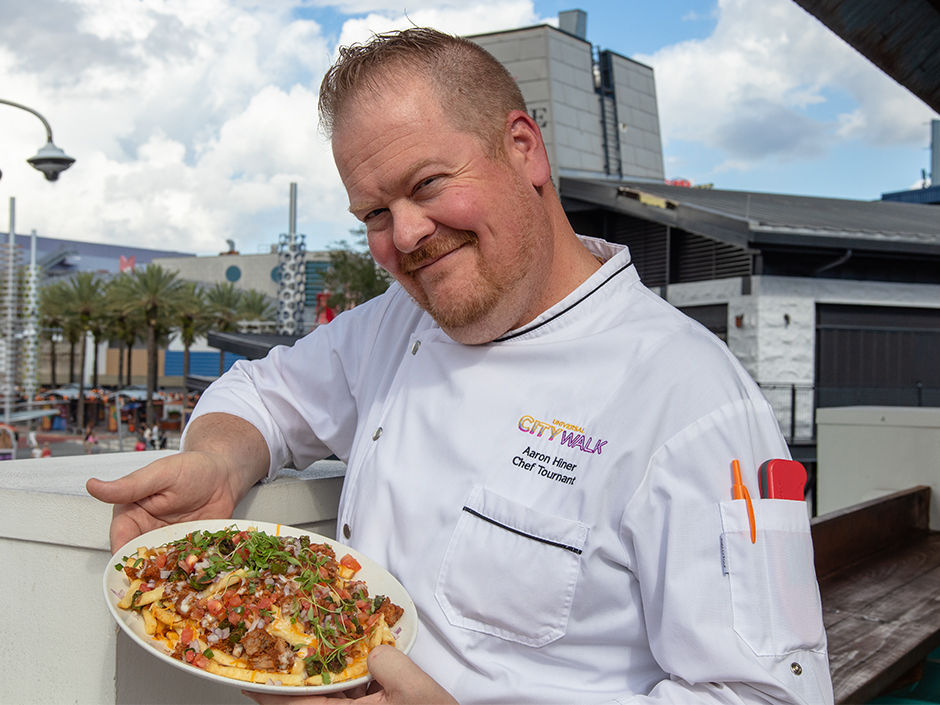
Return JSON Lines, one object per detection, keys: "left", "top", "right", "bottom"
{"left": 85, "top": 414, "right": 268, "bottom": 553}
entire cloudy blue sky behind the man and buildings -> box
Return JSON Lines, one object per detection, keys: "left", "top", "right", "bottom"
{"left": 0, "top": 0, "right": 940, "bottom": 254}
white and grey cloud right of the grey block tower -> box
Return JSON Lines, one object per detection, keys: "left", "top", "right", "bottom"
{"left": 635, "top": 0, "right": 932, "bottom": 173}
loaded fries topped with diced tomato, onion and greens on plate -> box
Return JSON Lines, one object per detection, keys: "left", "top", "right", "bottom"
{"left": 115, "top": 526, "right": 403, "bottom": 685}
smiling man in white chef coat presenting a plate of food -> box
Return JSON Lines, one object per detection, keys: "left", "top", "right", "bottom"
{"left": 88, "top": 29, "right": 832, "bottom": 703}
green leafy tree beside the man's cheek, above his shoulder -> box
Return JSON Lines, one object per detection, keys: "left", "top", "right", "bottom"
{"left": 323, "top": 228, "right": 393, "bottom": 311}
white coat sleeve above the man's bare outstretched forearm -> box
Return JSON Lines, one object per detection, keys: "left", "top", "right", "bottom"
{"left": 183, "top": 287, "right": 415, "bottom": 479}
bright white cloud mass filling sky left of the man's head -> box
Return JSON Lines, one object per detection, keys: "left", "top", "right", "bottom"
{"left": 0, "top": 0, "right": 537, "bottom": 253}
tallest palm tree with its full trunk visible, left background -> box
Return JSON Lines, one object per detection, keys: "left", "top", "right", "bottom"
{"left": 114, "top": 264, "right": 183, "bottom": 426}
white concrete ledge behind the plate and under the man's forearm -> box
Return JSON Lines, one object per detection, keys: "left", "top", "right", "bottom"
{"left": 0, "top": 451, "right": 345, "bottom": 705}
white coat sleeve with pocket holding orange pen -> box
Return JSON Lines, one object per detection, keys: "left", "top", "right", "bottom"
{"left": 622, "top": 398, "right": 833, "bottom": 705}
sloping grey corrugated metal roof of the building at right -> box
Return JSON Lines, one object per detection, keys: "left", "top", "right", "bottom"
{"left": 616, "top": 182, "right": 940, "bottom": 244}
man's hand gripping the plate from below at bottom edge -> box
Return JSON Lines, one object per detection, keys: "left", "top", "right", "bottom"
{"left": 242, "top": 646, "right": 457, "bottom": 705}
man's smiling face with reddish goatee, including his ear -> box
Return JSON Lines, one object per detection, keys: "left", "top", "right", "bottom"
{"left": 333, "top": 79, "right": 552, "bottom": 343}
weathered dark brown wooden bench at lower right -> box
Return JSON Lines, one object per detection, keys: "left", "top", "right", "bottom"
{"left": 812, "top": 487, "right": 940, "bottom": 703}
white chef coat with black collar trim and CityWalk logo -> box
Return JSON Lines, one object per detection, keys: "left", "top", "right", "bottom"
{"left": 189, "top": 238, "right": 832, "bottom": 705}
